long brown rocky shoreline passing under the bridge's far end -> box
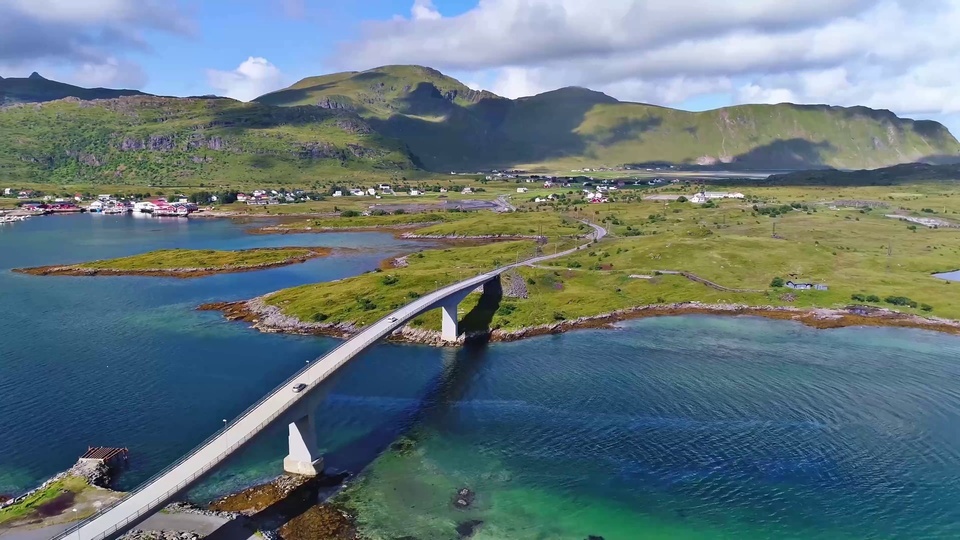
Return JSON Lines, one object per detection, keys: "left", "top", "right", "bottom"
{"left": 198, "top": 294, "right": 960, "bottom": 347}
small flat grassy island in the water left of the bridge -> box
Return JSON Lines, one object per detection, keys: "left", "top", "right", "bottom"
{"left": 14, "top": 247, "right": 330, "bottom": 278}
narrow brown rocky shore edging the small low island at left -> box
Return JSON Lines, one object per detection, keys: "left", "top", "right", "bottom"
{"left": 13, "top": 247, "right": 332, "bottom": 279}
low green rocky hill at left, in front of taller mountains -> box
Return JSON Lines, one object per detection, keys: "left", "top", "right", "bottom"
{"left": 0, "top": 96, "right": 418, "bottom": 185}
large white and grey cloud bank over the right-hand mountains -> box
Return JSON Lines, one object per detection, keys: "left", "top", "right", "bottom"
{"left": 337, "top": 0, "right": 960, "bottom": 132}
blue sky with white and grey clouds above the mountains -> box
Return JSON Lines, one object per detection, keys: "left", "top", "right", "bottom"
{"left": 0, "top": 0, "right": 960, "bottom": 134}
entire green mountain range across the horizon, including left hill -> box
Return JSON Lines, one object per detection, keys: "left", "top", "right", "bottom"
{"left": 0, "top": 66, "right": 960, "bottom": 183}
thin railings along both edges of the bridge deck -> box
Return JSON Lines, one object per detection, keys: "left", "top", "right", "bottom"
{"left": 51, "top": 227, "right": 600, "bottom": 540}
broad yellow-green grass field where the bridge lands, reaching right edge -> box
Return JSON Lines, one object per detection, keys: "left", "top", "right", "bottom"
{"left": 253, "top": 180, "right": 960, "bottom": 330}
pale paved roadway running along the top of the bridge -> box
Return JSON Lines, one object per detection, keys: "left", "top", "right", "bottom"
{"left": 54, "top": 223, "right": 606, "bottom": 540}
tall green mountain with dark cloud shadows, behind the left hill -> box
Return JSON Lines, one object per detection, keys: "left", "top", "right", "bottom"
{"left": 256, "top": 66, "right": 960, "bottom": 171}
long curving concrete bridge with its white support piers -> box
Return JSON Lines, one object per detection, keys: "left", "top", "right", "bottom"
{"left": 54, "top": 223, "right": 606, "bottom": 540}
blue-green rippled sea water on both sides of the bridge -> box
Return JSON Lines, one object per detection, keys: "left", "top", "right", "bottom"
{"left": 0, "top": 216, "right": 960, "bottom": 540}
